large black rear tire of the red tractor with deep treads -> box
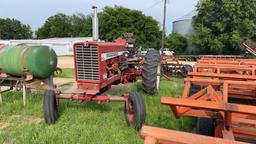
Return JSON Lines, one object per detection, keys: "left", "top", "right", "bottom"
{"left": 142, "top": 50, "right": 160, "bottom": 95}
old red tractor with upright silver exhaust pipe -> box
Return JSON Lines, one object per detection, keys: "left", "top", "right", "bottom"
{"left": 44, "top": 7, "right": 160, "bottom": 128}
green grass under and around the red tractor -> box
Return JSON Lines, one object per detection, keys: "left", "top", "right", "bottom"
{"left": 0, "top": 78, "right": 194, "bottom": 144}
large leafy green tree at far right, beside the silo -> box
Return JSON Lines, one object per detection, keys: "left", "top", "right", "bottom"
{"left": 191, "top": 0, "right": 256, "bottom": 54}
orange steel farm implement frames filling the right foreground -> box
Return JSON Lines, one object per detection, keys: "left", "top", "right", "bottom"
{"left": 141, "top": 58, "right": 256, "bottom": 144}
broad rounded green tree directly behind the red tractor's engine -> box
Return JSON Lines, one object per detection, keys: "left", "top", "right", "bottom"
{"left": 99, "top": 6, "right": 161, "bottom": 48}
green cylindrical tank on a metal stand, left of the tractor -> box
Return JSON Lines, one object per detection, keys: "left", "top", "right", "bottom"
{"left": 0, "top": 45, "right": 57, "bottom": 105}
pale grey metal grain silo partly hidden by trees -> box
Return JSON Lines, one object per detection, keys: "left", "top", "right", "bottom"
{"left": 173, "top": 10, "right": 197, "bottom": 52}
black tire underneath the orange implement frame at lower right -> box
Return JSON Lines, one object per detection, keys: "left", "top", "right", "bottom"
{"left": 196, "top": 118, "right": 214, "bottom": 136}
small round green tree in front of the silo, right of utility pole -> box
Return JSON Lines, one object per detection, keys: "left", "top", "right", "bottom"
{"left": 165, "top": 33, "right": 188, "bottom": 54}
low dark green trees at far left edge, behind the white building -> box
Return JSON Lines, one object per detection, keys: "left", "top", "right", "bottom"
{"left": 0, "top": 18, "right": 32, "bottom": 39}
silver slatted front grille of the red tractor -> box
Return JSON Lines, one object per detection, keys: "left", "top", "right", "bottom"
{"left": 76, "top": 45, "right": 99, "bottom": 80}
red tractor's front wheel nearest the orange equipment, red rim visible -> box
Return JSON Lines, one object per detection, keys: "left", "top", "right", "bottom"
{"left": 124, "top": 92, "right": 146, "bottom": 129}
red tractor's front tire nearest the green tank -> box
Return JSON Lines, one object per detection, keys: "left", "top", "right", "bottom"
{"left": 43, "top": 90, "right": 59, "bottom": 124}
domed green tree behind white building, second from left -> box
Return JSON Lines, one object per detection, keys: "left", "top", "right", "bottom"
{"left": 36, "top": 13, "right": 72, "bottom": 39}
